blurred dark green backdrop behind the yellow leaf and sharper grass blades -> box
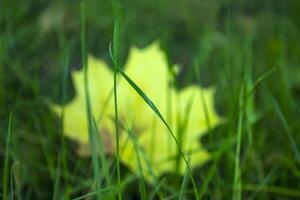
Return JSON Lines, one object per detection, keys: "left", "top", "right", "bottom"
{"left": 0, "top": 0, "right": 300, "bottom": 199}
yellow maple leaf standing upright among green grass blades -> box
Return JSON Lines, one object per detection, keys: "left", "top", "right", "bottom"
{"left": 51, "top": 42, "right": 221, "bottom": 181}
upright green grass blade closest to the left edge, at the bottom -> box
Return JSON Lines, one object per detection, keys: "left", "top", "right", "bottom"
{"left": 2, "top": 113, "right": 12, "bottom": 200}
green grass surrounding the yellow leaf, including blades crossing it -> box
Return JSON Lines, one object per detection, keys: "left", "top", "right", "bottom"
{"left": 0, "top": 0, "right": 300, "bottom": 199}
